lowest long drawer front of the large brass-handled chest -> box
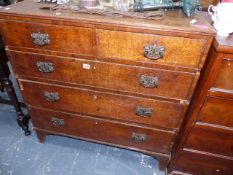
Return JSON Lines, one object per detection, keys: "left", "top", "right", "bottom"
{"left": 29, "top": 108, "right": 174, "bottom": 153}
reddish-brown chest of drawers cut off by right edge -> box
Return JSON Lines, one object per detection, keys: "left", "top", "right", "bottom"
{"left": 169, "top": 36, "right": 233, "bottom": 175}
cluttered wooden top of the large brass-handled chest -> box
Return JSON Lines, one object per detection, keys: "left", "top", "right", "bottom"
{"left": 0, "top": 0, "right": 214, "bottom": 35}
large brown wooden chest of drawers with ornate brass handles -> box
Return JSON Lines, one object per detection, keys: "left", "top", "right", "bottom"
{"left": 0, "top": 1, "right": 213, "bottom": 169}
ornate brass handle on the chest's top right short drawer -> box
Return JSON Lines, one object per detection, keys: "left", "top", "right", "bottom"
{"left": 144, "top": 44, "right": 165, "bottom": 60}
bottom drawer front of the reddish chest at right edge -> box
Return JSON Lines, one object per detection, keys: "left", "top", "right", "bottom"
{"left": 175, "top": 151, "right": 233, "bottom": 175}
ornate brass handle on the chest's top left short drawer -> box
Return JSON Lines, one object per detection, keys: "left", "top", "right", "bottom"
{"left": 31, "top": 32, "right": 50, "bottom": 46}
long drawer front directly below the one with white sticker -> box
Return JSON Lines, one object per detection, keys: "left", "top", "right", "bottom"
{"left": 20, "top": 80, "right": 183, "bottom": 128}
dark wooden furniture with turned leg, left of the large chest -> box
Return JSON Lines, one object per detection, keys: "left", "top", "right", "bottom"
{"left": 0, "top": 38, "right": 30, "bottom": 135}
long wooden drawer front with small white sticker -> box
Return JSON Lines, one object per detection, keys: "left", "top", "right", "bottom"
{"left": 8, "top": 52, "right": 194, "bottom": 99}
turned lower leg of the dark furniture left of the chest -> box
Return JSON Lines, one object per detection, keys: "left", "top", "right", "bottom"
{"left": 3, "top": 77, "right": 31, "bottom": 136}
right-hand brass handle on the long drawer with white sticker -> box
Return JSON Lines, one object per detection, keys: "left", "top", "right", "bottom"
{"left": 139, "top": 75, "right": 159, "bottom": 88}
